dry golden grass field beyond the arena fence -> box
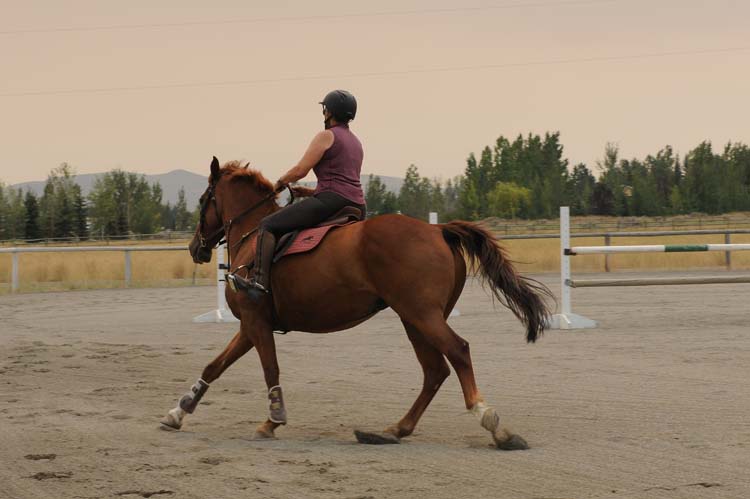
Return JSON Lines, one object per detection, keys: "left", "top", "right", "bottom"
{"left": 0, "top": 234, "right": 750, "bottom": 294}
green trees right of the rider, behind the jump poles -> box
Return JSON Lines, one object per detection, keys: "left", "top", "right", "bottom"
{"left": 366, "top": 133, "right": 750, "bottom": 220}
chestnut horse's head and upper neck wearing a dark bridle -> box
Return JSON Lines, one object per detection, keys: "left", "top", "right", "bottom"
{"left": 188, "top": 156, "right": 278, "bottom": 263}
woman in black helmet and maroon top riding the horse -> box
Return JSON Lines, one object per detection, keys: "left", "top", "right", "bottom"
{"left": 247, "top": 90, "right": 366, "bottom": 299}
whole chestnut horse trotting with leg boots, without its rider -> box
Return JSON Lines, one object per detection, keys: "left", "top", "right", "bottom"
{"left": 162, "top": 158, "right": 551, "bottom": 449}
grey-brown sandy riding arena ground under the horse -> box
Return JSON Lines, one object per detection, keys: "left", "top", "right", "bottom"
{"left": 0, "top": 275, "right": 750, "bottom": 499}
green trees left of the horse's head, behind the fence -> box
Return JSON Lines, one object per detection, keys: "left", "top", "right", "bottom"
{"left": 0, "top": 163, "right": 197, "bottom": 241}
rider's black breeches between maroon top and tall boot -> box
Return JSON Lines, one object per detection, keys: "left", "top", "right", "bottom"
{"left": 260, "top": 192, "right": 367, "bottom": 237}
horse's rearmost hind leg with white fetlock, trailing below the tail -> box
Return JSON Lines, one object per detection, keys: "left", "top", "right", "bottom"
{"left": 415, "top": 314, "right": 528, "bottom": 450}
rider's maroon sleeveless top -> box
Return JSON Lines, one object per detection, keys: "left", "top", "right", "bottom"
{"left": 313, "top": 124, "right": 365, "bottom": 204}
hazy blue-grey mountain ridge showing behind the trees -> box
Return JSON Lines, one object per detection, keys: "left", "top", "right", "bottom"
{"left": 13, "top": 170, "right": 404, "bottom": 209}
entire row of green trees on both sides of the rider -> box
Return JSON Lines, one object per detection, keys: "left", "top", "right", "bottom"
{"left": 0, "top": 132, "right": 750, "bottom": 240}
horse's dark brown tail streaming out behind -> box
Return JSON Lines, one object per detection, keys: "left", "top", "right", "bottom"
{"left": 441, "top": 221, "right": 554, "bottom": 343}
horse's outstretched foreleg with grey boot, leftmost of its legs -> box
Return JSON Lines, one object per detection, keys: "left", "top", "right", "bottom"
{"left": 161, "top": 330, "right": 253, "bottom": 430}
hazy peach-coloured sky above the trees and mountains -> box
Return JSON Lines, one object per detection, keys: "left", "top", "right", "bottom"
{"left": 0, "top": 0, "right": 750, "bottom": 183}
